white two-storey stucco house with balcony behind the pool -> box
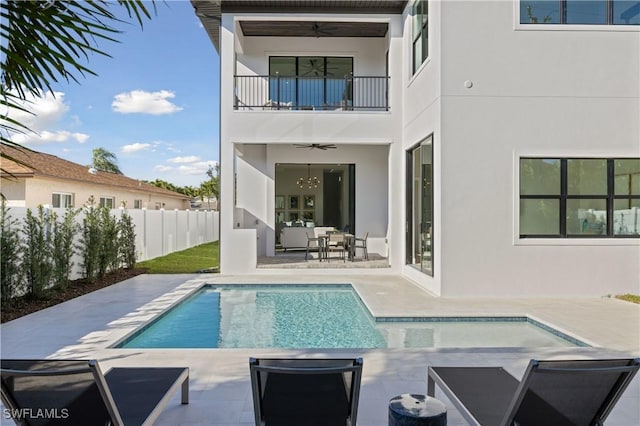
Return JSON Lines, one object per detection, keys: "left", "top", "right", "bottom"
{"left": 192, "top": 0, "right": 640, "bottom": 297}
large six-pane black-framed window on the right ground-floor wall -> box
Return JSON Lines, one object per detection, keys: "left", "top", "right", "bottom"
{"left": 520, "top": 158, "right": 640, "bottom": 238}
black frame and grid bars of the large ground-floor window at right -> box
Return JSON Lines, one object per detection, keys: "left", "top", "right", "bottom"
{"left": 515, "top": 155, "right": 640, "bottom": 241}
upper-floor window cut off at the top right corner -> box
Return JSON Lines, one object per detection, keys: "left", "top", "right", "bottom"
{"left": 520, "top": 0, "right": 640, "bottom": 25}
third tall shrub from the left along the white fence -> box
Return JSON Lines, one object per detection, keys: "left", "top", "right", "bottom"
{"left": 52, "top": 208, "right": 78, "bottom": 288}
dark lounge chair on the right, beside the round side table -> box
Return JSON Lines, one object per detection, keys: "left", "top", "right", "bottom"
{"left": 427, "top": 359, "right": 640, "bottom": 426}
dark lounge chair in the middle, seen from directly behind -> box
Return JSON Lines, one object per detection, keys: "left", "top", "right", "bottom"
{"left": 249, "top": 358, "right": 362, "bottom": 426}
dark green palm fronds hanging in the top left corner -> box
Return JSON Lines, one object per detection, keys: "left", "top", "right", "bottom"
{"left": 0, "top": 0, "right": 156, "bottom": 168}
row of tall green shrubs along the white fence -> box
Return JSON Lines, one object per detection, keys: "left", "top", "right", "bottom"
{"left": 0, "top": 197, "right": 136, "bottom": 308}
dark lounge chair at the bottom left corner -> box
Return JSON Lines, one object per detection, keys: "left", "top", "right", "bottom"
{"left": 0, "top": 359, "right": 189, "bottom": 426}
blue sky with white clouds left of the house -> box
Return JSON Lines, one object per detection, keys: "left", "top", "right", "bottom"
{"left": 4, "top": 0, "right": 219, "bottom": 187}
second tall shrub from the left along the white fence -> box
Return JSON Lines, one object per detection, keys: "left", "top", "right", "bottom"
{"left": 22, "top": 206, "right": 53, "bottom": 298}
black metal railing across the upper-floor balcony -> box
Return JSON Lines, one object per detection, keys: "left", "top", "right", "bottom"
{"left": 233, "top": 75, "right": 389, "bottom": 111}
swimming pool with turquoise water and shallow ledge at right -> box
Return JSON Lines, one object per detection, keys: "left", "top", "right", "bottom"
{"left": 116, "top": 284, "right": 587, "bottom": 349}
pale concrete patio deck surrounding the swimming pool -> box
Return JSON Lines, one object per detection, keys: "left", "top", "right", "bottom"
{"left": 0, "top": 274, "right": 640, "bottom": 426}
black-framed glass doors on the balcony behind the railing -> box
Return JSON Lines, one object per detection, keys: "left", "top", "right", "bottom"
{"left": 269, "top": 56, "right": 353, "bottom": 109}
